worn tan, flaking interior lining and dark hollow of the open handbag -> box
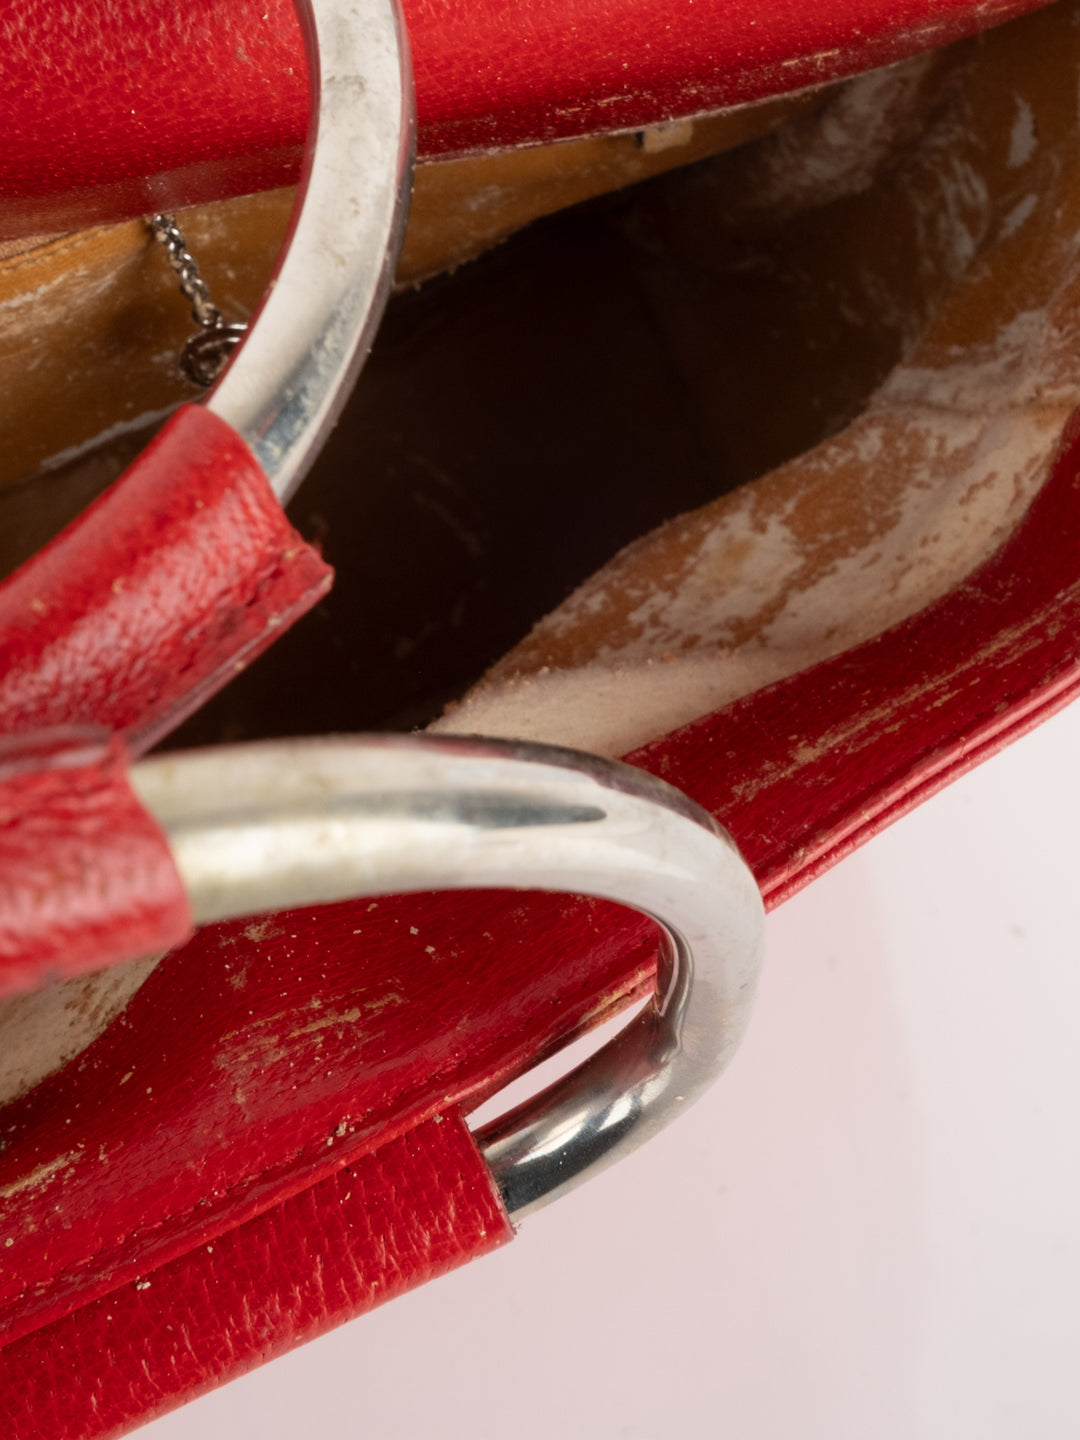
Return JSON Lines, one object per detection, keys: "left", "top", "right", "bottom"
{"left": 0, "top": 0, "right": 1080, "bottom": 1097}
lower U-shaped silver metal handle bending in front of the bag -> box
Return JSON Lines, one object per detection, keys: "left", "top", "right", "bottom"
{"left": 131, "top": 736, "right": 763, "bottom": 1218}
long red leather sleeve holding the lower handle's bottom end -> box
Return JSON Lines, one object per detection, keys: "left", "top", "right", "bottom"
{"left": 0, "top": 1115, "right": 511, "bottom": 1440}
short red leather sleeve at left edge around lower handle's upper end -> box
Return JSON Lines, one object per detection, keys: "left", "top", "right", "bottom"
{"left": 0, "top": 732, "right": 192, "bottom": 995}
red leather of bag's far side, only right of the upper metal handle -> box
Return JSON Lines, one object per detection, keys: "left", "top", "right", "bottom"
{"left": 405, "top": 0, "right": 1044, "bottom": 154}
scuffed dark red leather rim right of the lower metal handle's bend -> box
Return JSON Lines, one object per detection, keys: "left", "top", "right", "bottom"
{"left": 668, "top": 413, "right": 1080, "bottom": 909}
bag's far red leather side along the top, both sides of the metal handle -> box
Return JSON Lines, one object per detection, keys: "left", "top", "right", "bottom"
{"left": 0, "top": 0, "right": 1045, "bottom": 238}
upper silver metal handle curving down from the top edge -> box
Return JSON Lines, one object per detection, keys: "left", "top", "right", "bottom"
{"left": 207, "top": 0, "right": 415, "bottom": 504}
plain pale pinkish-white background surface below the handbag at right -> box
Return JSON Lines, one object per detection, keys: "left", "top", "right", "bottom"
{"left": 143, "top": 694, "right": 1080, "bottom": 1440}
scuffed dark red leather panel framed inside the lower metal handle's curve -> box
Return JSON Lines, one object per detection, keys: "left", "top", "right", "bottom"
{"left": 0, "top": 891, "right": 654, "bottom": 1344}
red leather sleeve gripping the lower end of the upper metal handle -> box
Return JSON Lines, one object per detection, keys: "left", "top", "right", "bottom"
{"left": 0, "top": 405, "right": 333, "bottom": 752}
